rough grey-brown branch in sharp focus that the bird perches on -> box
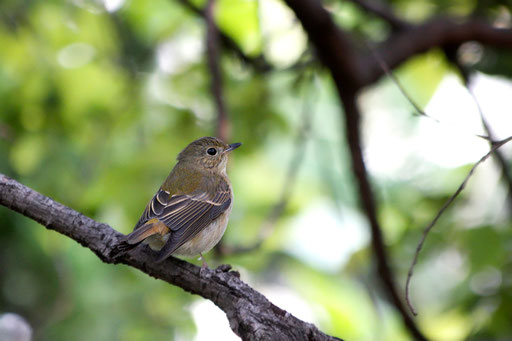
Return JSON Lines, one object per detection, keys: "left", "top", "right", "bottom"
{"left": 0, "top": 174, "right": 340, "bottom": 341}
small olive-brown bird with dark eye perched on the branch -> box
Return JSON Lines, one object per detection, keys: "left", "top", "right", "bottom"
{"left": 121, "top": 137, "right": 242, "bottom": 268}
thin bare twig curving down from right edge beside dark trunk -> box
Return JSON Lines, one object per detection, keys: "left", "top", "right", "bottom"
{"left": 405, "top": 136, "right": 512, "bottom": 316}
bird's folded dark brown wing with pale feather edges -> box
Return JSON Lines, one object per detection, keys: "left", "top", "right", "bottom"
{"left": 135, "top": 180, "right": 231, "bottom": 261}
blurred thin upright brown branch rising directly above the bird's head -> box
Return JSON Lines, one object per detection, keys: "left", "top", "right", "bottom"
{"left": 204, "top": 0, "right": 230, "bottom": 141}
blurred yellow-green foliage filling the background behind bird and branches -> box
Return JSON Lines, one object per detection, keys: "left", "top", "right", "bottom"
{"left": 0, "top": 0, "right": 512, "bottom": 340}
